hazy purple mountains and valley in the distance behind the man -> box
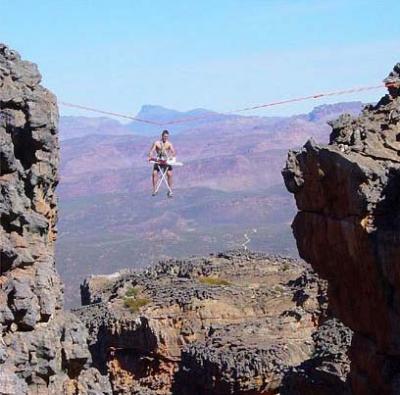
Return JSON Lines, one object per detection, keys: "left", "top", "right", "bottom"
{"left": 56, "top": 102, "right": 362, "bottom": 304}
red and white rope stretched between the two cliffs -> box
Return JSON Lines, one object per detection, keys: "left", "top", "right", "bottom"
{"left": 59, "top": 82, "right": 399, "bottom": 126}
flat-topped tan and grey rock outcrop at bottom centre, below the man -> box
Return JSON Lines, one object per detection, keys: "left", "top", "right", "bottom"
{"left": 75, "top": 251, "right": 346, "bottom": 395}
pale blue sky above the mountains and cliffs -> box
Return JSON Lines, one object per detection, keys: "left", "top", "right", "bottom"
{"left": 0, "top": 0, "right": 400, "bottom": 115}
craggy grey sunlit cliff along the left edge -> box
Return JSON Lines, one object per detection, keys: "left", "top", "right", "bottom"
{"left": 0, "top": 44, "right": 110, "bottom": 394}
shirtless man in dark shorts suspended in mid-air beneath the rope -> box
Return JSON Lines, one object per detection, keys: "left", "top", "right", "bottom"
{"left": 148, "top": 130, "right": 176, "bottom": 197}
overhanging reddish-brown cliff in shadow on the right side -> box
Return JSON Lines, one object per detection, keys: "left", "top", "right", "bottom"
{"left": 283, "top": 63, "right": 400, "bottom": 394}
